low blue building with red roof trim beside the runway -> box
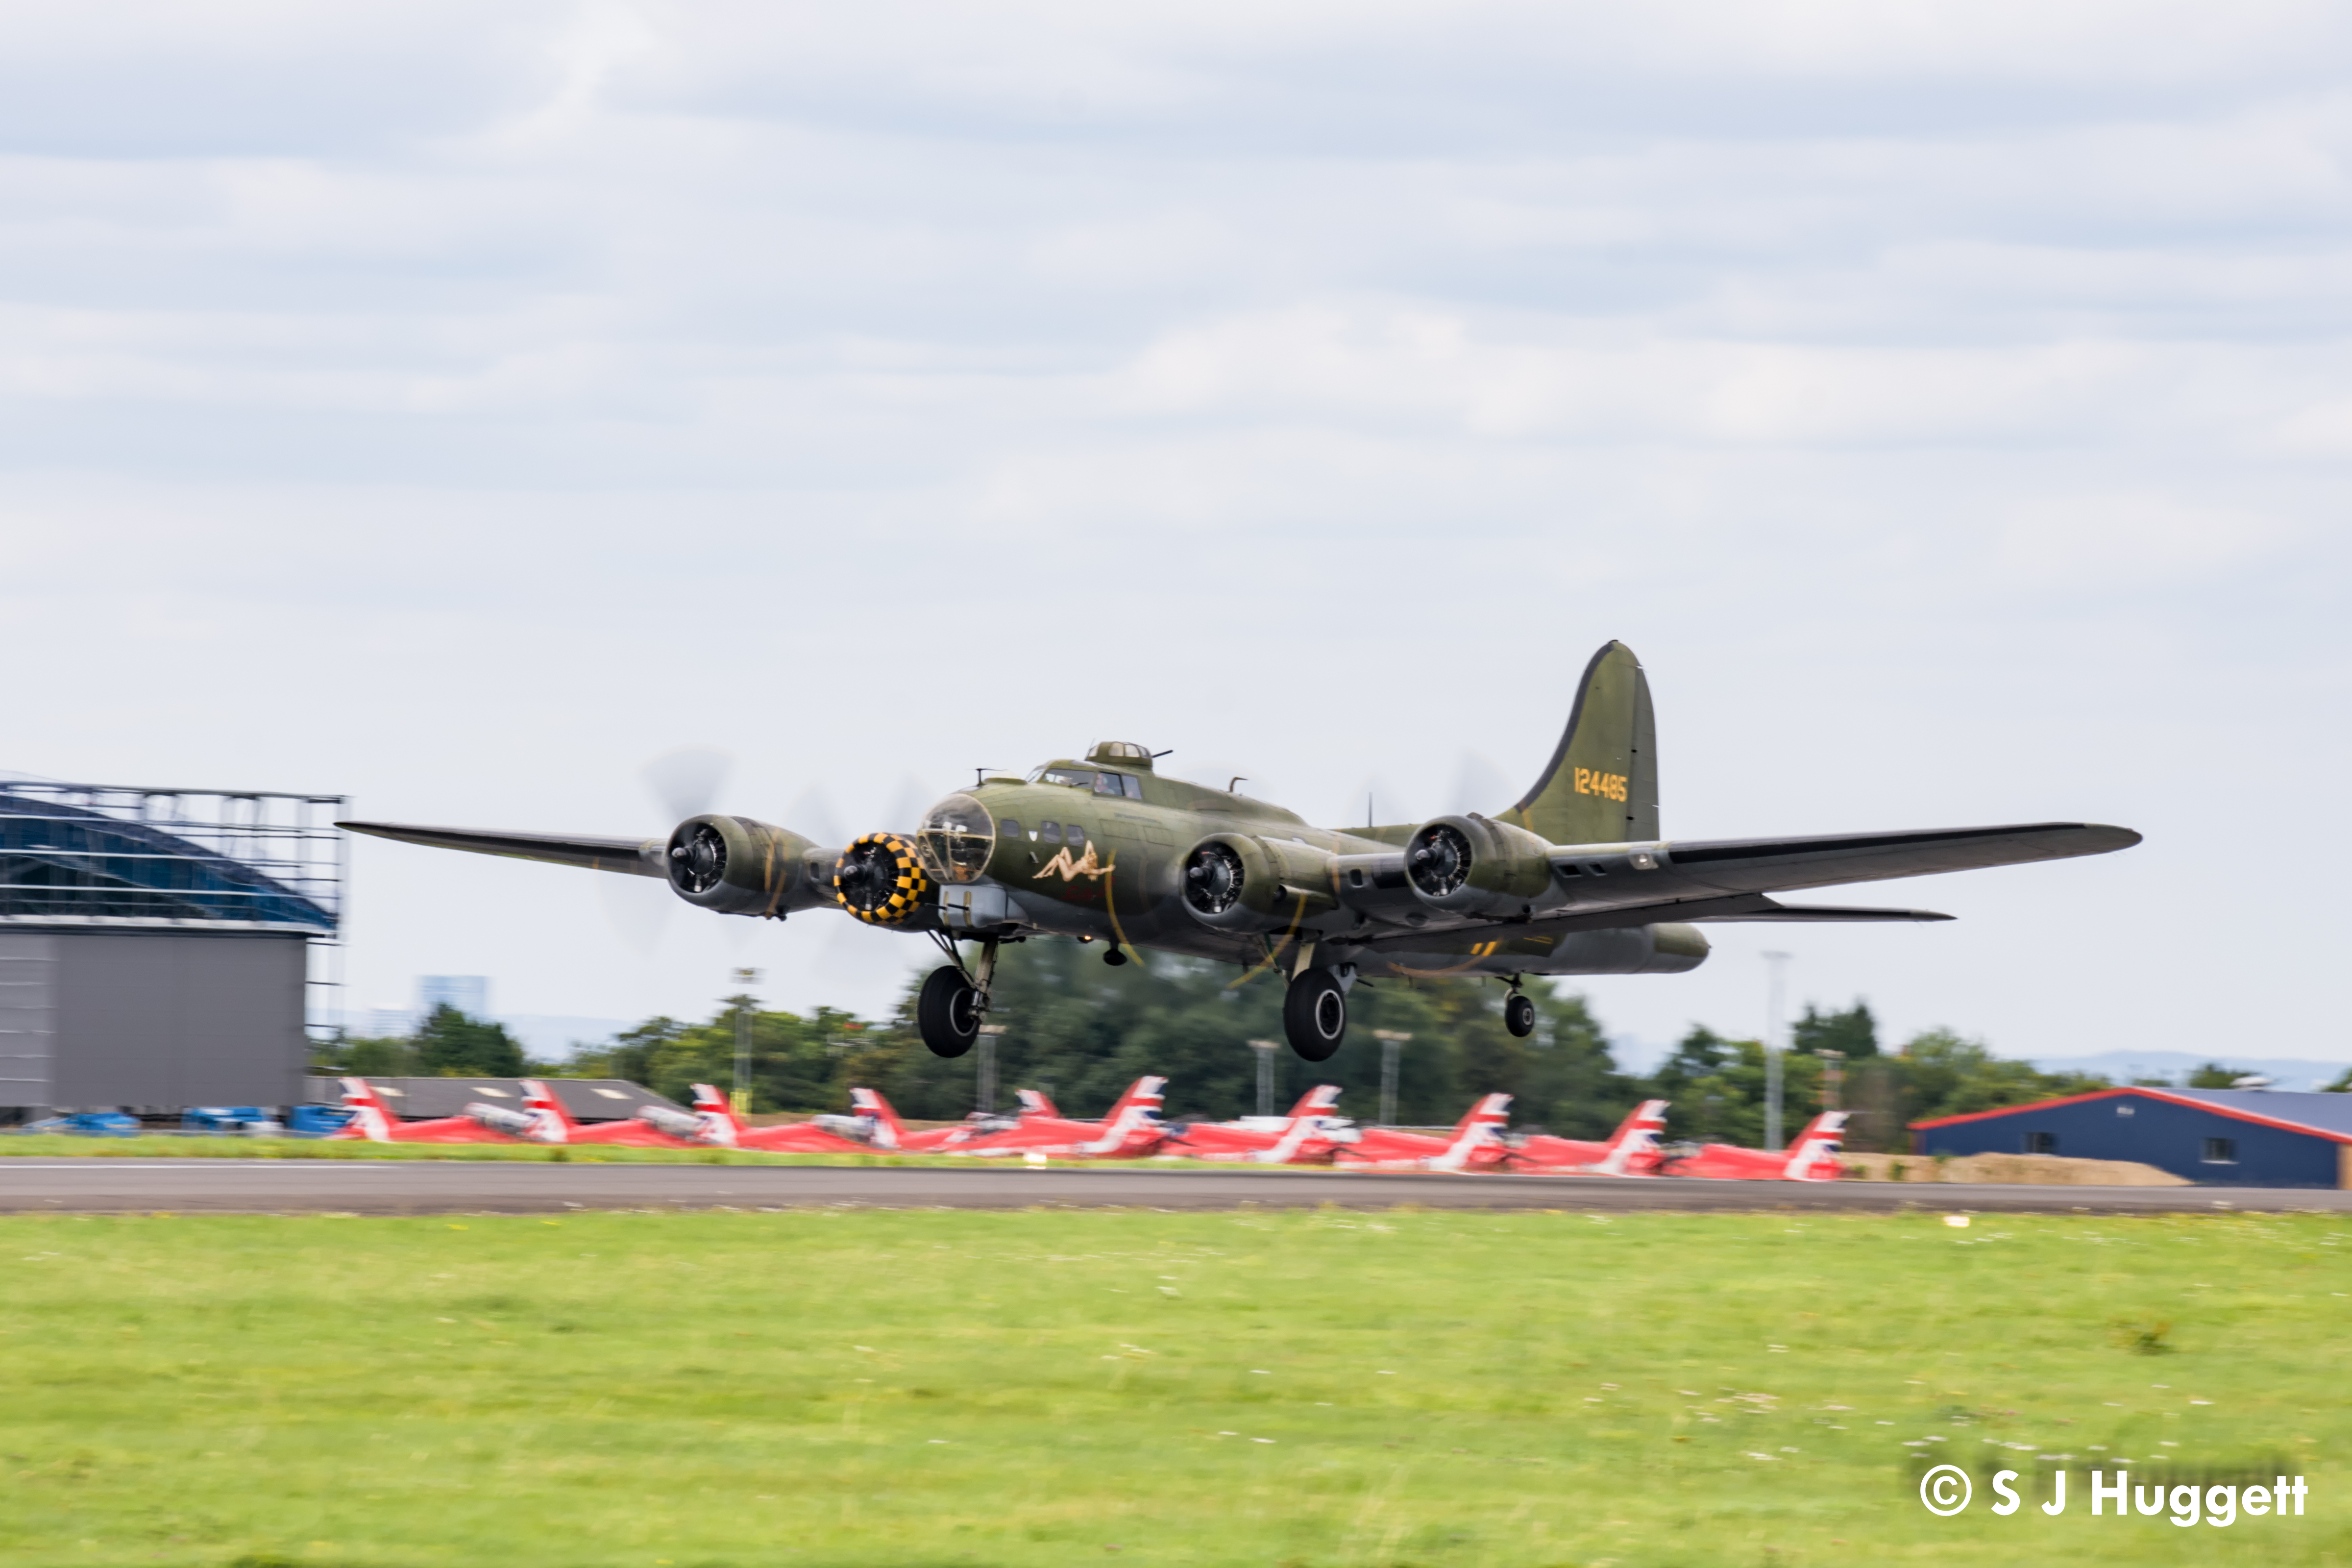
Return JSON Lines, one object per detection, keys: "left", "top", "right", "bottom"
{"left": 1910, "top": 1088, "right": 2352, "bottom": 1187}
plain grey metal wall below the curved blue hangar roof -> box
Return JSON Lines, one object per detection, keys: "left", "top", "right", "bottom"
{"left": 0, "top": 931, "right": 308, "bottom": 1107}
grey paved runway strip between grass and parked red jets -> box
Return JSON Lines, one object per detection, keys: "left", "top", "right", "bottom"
{"left": 0, "top": 1159, "right": 2352, "bottom": 1213}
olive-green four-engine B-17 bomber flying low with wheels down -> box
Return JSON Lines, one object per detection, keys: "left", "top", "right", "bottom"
{"left": 341, "top": 642, "right": 2140, "bottom": 1063}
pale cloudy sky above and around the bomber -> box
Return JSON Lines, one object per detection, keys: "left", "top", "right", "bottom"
{"left": 0, "top": 0, "right": 2352, "bottom": 1058}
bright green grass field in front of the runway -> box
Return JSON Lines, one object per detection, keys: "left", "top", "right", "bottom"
{"left": 0, "top": 1211, "right": 2352, "bottom": 1568}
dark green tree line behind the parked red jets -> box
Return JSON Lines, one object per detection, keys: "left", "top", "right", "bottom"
{"left": 320, "top": 940, "right": 2237, "bottom": 1150}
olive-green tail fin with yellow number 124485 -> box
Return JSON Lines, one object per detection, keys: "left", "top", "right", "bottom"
{"left": 1496, "top": 642, "right": 1658, "bottom": 844}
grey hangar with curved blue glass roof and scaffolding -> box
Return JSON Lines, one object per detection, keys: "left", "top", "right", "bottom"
{"left": 0, "top": 776, "right": 346, "bottom": 1117}
